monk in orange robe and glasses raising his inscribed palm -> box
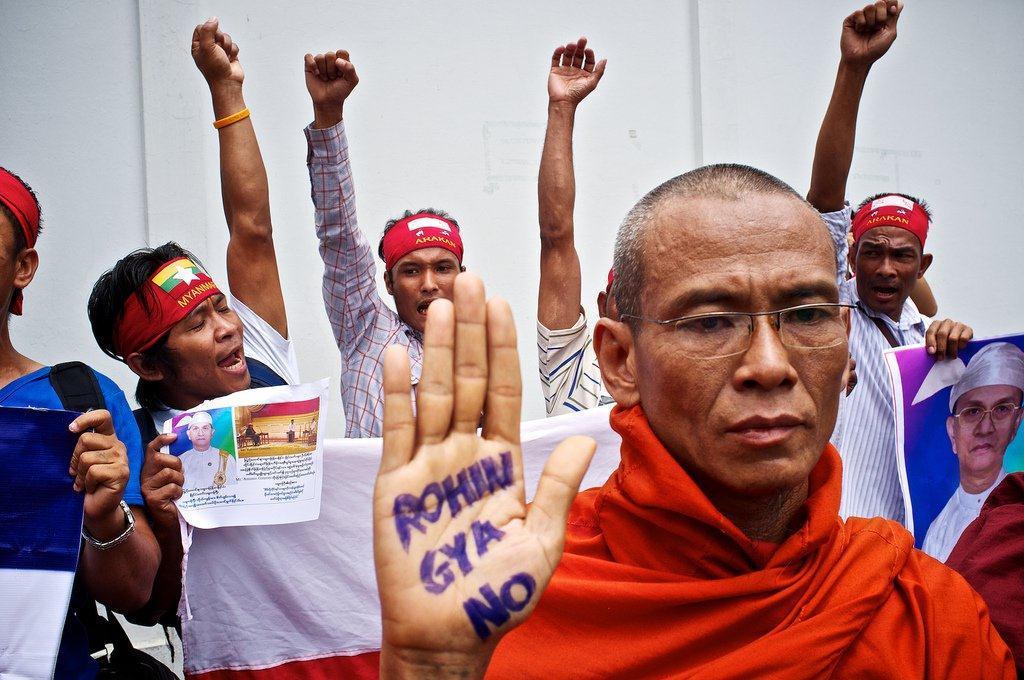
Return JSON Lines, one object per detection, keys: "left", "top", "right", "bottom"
{"left": 374, "top": 165, "right": 1015, "bottom": 680}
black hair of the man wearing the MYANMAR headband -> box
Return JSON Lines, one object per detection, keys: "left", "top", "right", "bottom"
{"left": 88, "top": 242, "right": 202, "bottom": 409}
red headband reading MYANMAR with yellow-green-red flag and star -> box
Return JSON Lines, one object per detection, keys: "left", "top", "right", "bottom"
{"left": 114, "top": 257, "right": 220, "bottom": 357}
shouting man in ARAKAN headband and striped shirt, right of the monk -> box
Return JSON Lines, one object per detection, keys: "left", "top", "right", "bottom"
{"left": 807, "top": 0, "right": 974, "bottom": 522}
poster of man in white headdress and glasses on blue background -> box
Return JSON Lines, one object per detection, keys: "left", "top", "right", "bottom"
{"left": 886, "top": 335, "right": 1024, "bottom": 561}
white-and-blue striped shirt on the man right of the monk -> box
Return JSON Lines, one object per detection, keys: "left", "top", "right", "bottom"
{"left": 821, "top": 208, "right": 930, "bottom": 523}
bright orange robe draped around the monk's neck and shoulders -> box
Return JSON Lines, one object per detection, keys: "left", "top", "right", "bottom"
{"left": 487, "top": 407, "right": 1015, "bottom": 680}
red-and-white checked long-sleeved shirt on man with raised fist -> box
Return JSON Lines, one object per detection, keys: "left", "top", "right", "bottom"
{"left": 305, "top": 122, "right": 423, "bottom": 438}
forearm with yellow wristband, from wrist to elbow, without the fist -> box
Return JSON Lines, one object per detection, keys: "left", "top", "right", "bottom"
{"left": 210, "top": 81, "right": 271, "bottom": 233}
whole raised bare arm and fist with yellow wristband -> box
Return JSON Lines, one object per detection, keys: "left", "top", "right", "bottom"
{"left": 191, "top": 18, "right": 288, "bottom": 338}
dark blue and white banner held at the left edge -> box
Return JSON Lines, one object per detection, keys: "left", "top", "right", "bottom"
{"left": 0, "top": 407, "right": 84, "bottom": 678}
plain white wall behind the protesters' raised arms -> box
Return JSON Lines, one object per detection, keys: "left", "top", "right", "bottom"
{"left": 0, "top": 0, "right": 1024, "bottom": 435}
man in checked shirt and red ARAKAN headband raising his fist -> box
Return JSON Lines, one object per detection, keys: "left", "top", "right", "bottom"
{"left": 305, "top": 50, "right": 465, "bottom": 437}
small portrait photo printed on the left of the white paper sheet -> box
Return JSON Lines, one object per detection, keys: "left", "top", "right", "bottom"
{"left": 168, "top": 408, "right": 238, "bottom": 493}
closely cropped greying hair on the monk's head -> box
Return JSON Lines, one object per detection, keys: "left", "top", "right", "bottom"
{"left": 609, "top": 163, "right": 819, "bottom": 332}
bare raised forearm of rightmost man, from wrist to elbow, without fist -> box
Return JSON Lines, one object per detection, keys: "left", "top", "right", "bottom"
{"left": 807, "top": 60, "right": 870, "bottom": 212}
